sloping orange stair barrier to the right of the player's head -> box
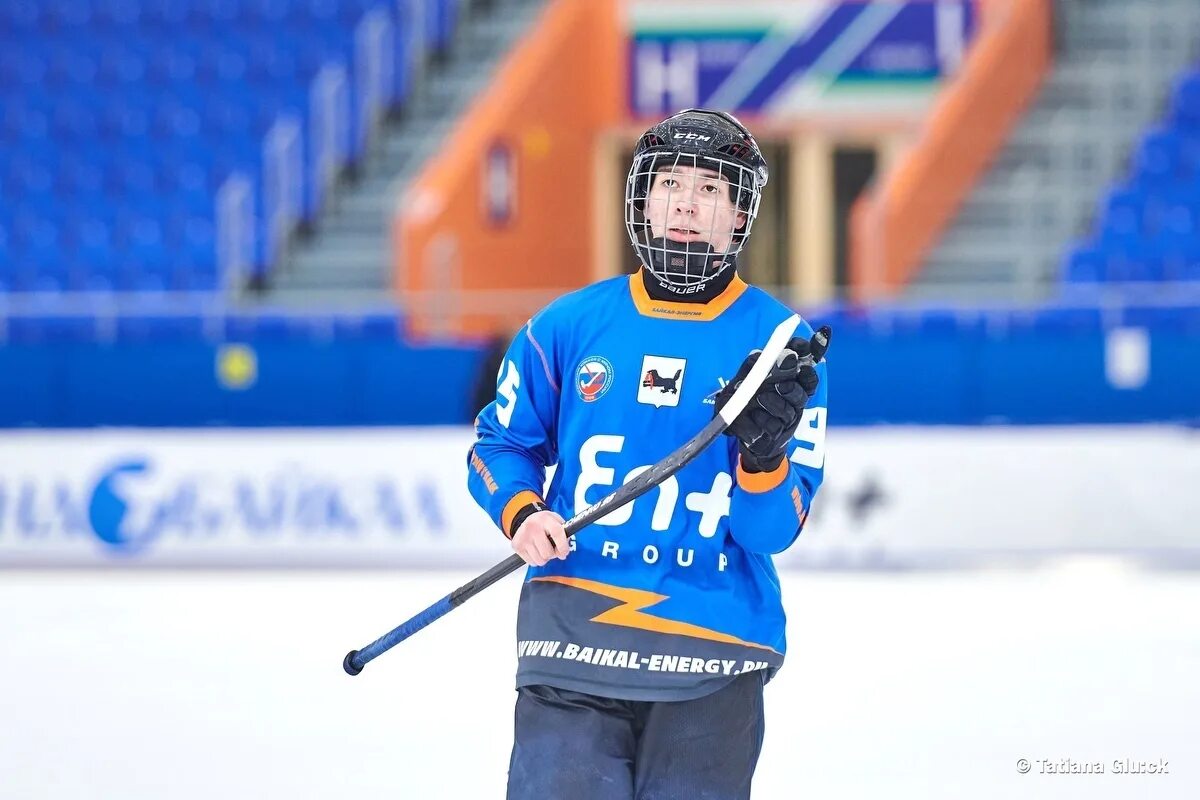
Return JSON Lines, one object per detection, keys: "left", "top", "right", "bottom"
{"left": 850, "top": 0, "right": 1052, "bottom": 300}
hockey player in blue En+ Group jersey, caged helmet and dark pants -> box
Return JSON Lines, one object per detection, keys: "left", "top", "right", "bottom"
{"left": 468, "top": 109, "right": 828, "bottom": 800}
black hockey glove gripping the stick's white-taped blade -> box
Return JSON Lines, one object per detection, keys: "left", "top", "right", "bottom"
{"left": 715, "top": 325, "right": 832, "bottom": 473}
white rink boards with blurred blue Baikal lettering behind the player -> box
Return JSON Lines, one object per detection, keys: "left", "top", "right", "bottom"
{"left": 0, "top": 426, "right": 1200, "bottom": 569}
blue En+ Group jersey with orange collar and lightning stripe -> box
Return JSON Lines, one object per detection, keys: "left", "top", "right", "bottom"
{"left": 468, "top": 273, "right": 827, "bottom": 700}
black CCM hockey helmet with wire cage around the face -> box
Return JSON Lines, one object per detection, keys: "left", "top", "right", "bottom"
{"left": 625, "top": 108, "right": 769, "bottom": 293}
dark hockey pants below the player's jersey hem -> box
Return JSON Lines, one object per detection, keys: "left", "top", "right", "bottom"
{"left": 508, "top": 673, "right": 763, "bottom": 800}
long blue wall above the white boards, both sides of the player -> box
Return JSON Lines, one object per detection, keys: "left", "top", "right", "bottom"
{"left": 0, "top": 314, "right": 1200, "bottom": 427}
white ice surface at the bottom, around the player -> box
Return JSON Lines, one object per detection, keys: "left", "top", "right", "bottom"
{"left": 0, "top": 564, "right": 1200, "bottom": 800}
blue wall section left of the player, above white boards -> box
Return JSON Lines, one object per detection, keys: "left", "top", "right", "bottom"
{"left": 0, "top": 342, "right": 482, "bottom": 427}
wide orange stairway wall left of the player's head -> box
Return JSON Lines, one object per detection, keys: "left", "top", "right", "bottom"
{"left": 394, "top": 0, "right": 625, "bottom": 335}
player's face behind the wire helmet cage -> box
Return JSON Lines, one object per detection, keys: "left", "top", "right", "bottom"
{"left": 646, "top": 164, "right": 746, "bottom": 253}
